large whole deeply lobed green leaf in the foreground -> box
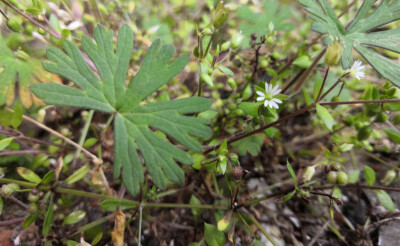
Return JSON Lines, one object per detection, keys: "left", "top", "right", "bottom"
{"left": 31, "top": 26, "right": 211, "bottom": 195}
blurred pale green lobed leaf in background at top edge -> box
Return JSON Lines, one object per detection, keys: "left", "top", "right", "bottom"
{"left": 237, "top": 0, "right": 296, "bottom": 48}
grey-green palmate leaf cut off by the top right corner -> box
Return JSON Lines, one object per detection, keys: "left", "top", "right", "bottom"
{"left": 299, "top": 0, "right": 400, "bottom": 87}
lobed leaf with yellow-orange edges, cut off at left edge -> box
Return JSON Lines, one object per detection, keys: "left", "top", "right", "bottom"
{"left": 0, "top": 35, "right": 57, "bottom": 108}
